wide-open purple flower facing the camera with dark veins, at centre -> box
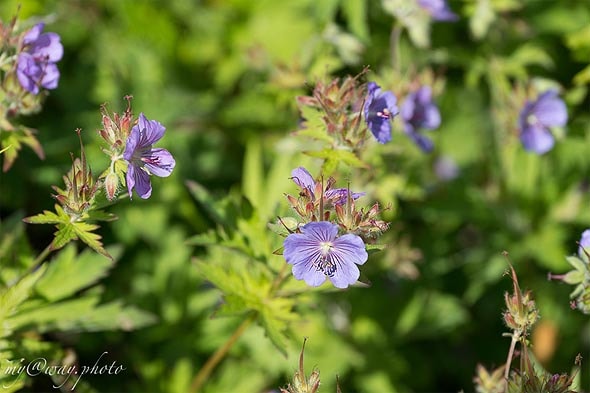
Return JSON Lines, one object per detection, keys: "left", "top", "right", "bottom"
{"left": 283, "top": 221, "right": 368, "bottom": 288}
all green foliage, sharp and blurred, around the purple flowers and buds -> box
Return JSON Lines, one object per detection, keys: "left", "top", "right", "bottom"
{"left": 0, "top": 0, "right": 590, "bottom": 393}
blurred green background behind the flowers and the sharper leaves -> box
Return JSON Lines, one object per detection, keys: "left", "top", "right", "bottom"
{"left": 0, "top": 0, "right": 590, "bottom": 392}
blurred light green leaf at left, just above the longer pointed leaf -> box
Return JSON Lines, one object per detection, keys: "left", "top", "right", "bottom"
{"left": 35, "top": 245, "right": 122, "bottom": 302}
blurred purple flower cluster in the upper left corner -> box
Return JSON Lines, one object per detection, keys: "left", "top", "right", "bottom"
{"left": 16, "top": 23, "right": 63, "bottom": 94}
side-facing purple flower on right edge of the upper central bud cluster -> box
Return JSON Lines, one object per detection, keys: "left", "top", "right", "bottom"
{"left": 364, "top": 82, "right": 398, "bottom": 143}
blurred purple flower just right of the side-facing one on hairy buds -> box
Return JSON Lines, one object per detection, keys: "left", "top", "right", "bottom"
{"left": 401, "top": 86, "right": 440, "bottom": 152}
